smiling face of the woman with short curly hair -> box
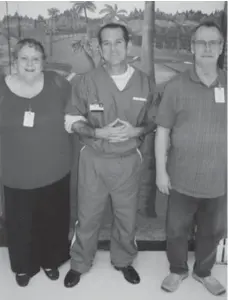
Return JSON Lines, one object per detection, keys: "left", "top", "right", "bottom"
{"left": 16, "top": 45, "right": 43, "bottom": 81}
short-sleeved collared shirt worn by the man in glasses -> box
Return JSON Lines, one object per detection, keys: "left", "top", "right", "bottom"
{"left": 156, "top": 68, "right": 227, "bottom": 198}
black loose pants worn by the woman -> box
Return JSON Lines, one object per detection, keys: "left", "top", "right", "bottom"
{"left": 4, "top": 174, "right": 70, "bottom": 276}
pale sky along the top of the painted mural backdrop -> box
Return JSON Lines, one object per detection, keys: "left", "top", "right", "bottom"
{"left": 0, "top": 1, "right": 224, "bottom": 19}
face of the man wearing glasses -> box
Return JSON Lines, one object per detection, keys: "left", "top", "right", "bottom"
{"left": 191, "top": 26, "right": 223, "bottom": 65}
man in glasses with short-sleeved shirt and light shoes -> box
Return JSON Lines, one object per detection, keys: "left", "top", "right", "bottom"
{"left": 155, "top": 21, "right": 227, "bottom": 295}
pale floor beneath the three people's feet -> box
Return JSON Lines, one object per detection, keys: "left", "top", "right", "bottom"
{"left": 0, "top": 248, "right": 227, "bottom": 300}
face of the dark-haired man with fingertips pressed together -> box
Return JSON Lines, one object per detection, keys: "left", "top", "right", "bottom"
{"left": 100, "top": 28, "right": 128, "bottom": 66}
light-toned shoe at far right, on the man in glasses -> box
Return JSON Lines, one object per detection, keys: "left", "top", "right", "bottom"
{"left": 192, "top": 273, "right": 226, "bottom": 296}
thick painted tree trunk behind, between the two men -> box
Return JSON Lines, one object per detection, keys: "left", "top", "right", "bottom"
{"left": 139, "top": 1, "right": 156, "bottom": 217}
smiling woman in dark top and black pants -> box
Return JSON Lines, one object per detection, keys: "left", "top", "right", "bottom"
{"left": 0, "top": 39, "right": 72, "bottom": 286}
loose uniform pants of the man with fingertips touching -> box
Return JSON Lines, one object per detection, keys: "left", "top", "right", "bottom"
{"left": 70, "top": 146, "right": 142, "bottom": 273}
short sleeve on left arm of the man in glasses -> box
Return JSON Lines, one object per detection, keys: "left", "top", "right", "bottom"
{"left": 155, "top": 82, "right": 177, "bottom": 129}
